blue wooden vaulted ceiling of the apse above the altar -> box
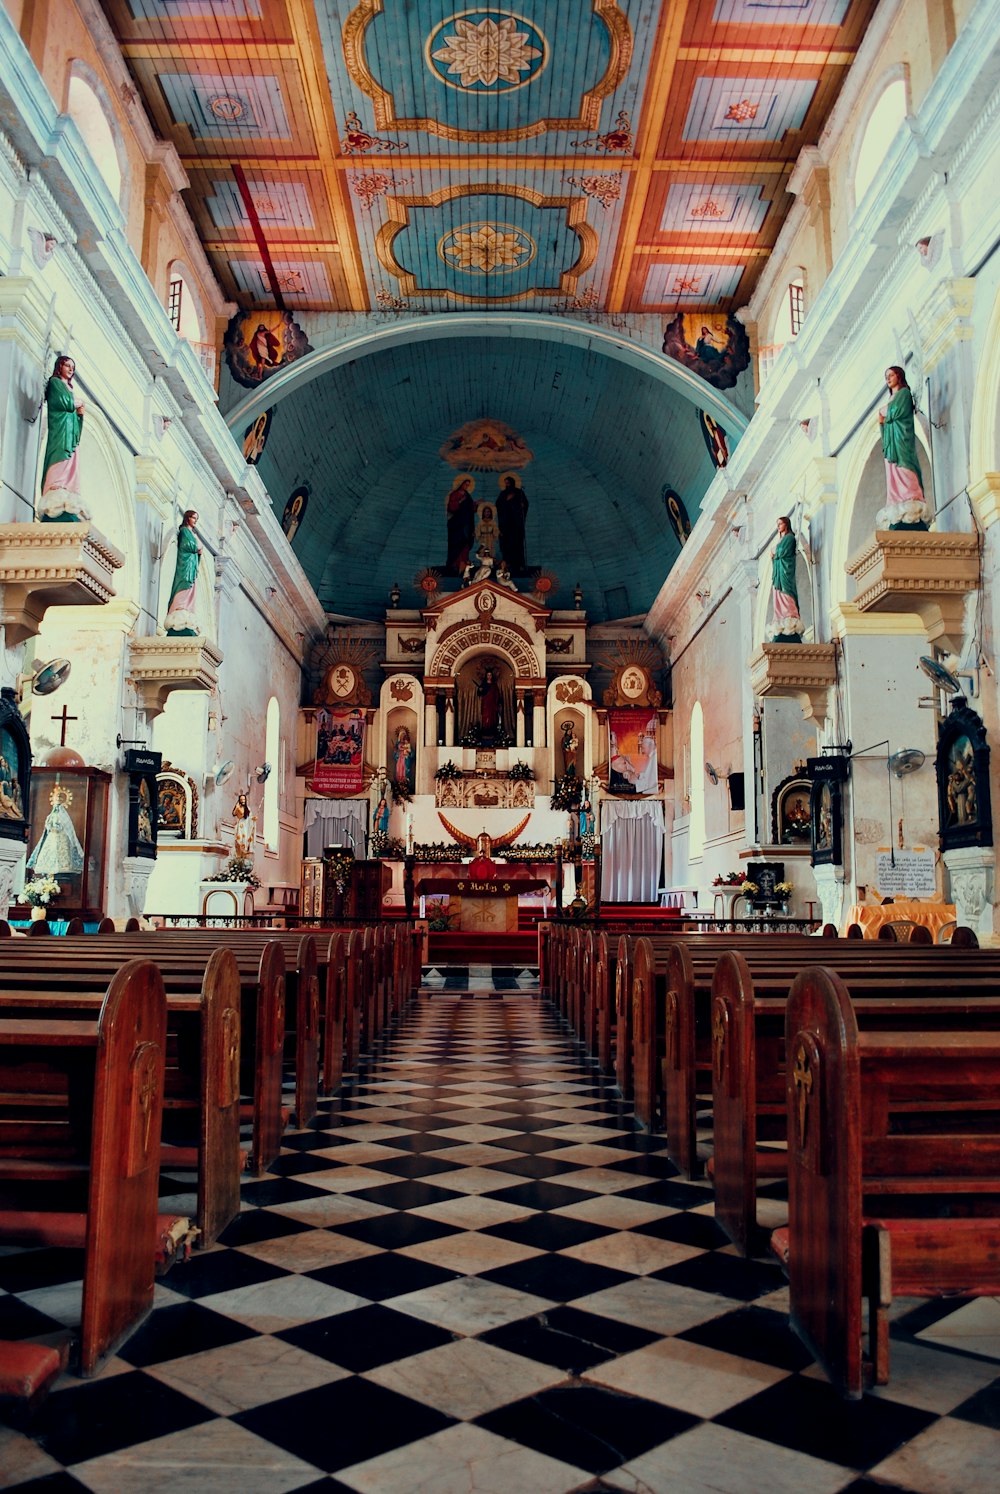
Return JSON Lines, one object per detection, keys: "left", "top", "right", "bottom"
{"left": 251, "top": 329, "right": 726, "bottom": 622}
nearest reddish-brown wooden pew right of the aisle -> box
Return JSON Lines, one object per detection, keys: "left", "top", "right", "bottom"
{"left": 774, "top": 970, "right": 1000, "bottom": 1398}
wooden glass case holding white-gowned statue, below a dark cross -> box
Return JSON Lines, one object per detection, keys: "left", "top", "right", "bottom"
{"left": 27, "top": 770, "right": 111, "bottom": 919}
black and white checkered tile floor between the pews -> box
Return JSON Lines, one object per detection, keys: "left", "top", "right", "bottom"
{"left": 0, "top": 989, "right": 1000, "bottom": 1494}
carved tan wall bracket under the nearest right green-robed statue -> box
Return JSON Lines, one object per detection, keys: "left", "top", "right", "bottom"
{"left": 846, "top": 529, "right": 979, "bottom": 653}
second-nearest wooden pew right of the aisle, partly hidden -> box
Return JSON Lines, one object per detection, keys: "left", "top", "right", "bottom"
{"left": 710, "top": 953, "right": 1000, "bottom": 1255}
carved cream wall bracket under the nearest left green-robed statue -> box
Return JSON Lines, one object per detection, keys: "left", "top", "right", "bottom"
{"left": 0, "top": 521, "right": 126, "bottom": 647}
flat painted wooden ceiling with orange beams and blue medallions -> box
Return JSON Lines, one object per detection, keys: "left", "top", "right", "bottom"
{"left": 103, "top": 0, "right": 876, "bottom": 314}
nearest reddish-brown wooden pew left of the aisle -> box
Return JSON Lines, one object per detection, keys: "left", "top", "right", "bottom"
{"left": 0, "top": 961, "right": 166, "bottom": 1376}
